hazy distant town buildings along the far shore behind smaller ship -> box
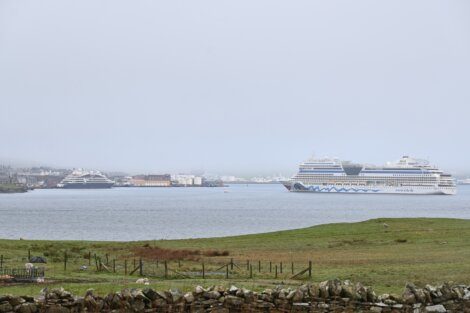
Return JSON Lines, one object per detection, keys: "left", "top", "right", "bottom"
{"left": 0, "top": 165, "right": 287, "bottom": 192}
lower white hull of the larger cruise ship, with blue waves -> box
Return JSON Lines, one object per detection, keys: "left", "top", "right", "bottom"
{"left": 284, "top": 182, "right": 457, "bottom": 195}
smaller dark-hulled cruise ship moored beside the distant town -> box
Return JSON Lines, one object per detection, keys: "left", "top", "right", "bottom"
{"left": 57, "top": 170, "right": 114, "bottom": 189}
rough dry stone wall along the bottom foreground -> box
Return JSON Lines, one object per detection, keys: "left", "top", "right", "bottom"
{"left": 0, "top": 280, "right": 470, "bottom": 313}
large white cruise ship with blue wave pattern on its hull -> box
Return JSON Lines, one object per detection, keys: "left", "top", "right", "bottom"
{"left": 284, "top": 156, "right": 457, "bottom": 195}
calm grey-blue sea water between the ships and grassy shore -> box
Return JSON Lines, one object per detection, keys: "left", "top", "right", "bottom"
{"left": 0, "top": 185, "right": 470, "bottom": 241}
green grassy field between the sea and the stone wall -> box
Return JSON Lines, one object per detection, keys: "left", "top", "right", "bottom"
{"left": 0, "top": 218, "right": 470, "bottom": 295}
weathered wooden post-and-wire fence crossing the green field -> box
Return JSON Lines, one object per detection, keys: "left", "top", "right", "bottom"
{"left": 0, "top": 250, "right": 313, "bottom": 280}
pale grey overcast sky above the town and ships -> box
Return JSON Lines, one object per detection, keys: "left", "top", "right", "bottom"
{"left": 0, "top": 0, "right": 470, "bottom": 175}
